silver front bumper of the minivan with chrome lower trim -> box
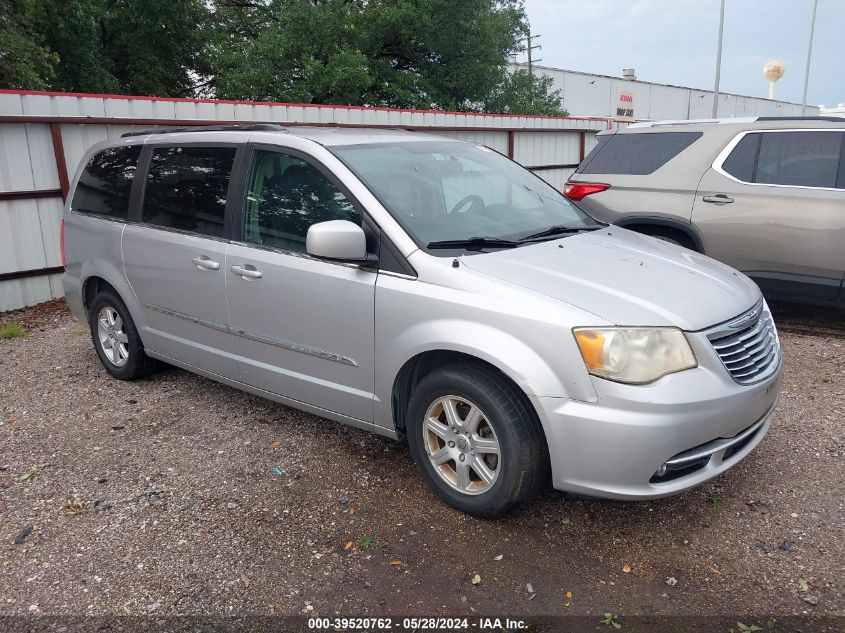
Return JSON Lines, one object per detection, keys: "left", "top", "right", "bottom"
{"left": 532, "top": 345, "right": 783, "bottom": 500}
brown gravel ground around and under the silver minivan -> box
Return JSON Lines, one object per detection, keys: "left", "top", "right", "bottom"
{"left": 0, "top": 303, "right": 845, "bottom": 628}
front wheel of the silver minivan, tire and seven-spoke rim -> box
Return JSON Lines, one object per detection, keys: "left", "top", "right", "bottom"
{"left": 407, "top": 363, "right": 548, "bottom": 518}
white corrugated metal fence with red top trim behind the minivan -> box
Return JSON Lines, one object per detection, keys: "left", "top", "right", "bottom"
{"left": 0, "top": 90, "right": 613, "bottom": 311}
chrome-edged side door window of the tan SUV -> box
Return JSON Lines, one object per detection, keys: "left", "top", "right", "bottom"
{"left": 722, "top": 131, "right": 845, "bottom": 188}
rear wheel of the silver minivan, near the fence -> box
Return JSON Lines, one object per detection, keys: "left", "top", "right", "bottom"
{"left": 88, "top": 292, "right": 157, "bottom": 380}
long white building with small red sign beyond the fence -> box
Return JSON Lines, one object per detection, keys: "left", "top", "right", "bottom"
{"left": 511, "top": 64, "right": 819, "bottom": 121}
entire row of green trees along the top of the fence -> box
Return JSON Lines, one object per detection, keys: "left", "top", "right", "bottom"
{"left": 0, "top": 0, "right": 562, "bottom": 114}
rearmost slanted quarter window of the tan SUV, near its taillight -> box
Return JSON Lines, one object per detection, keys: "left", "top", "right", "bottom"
{"left": 580, "top": 132, "right": 702, "bottom": 176}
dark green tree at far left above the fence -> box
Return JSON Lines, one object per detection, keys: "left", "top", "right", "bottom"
{"left": 0, "top": 0, "right": 209, "bottom": 96}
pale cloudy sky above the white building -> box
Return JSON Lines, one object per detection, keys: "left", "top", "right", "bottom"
{"left": 517, "top": 0, "right": 845, "bottom": 107}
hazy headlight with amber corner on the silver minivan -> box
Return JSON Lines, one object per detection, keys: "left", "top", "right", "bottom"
{"left": 573, "top": 328, "right": 698, "bottom": 385}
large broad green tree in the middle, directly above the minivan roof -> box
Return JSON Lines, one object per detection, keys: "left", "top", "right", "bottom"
{"left": 211, "top": 0, "right": 568, "bottom": 111}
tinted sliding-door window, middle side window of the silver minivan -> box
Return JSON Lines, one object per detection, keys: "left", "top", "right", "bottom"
{"left": 142, "top": 146, "right": 235, "bottom": 237}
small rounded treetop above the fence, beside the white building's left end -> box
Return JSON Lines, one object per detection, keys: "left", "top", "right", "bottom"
{"left": 484, "top": 68, "right": 569, "bottom": 116}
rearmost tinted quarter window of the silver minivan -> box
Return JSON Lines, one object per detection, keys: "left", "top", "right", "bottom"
{"left": 71, "top": 145, "right": 141, "bottom": 220}
